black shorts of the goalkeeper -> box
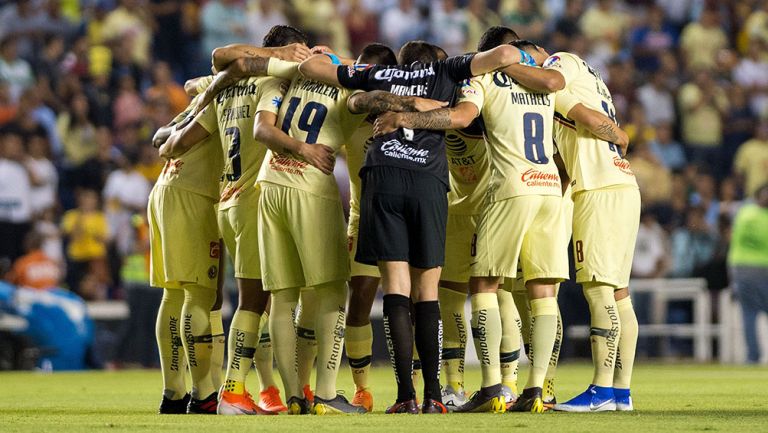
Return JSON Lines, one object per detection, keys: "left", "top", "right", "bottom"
{"left": 355, "top": 166, "right": 448, "bottom": 269}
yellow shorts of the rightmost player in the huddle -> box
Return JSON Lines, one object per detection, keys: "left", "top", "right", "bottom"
{"left": 573, "top": 186, "right": 640, "bottom": 289}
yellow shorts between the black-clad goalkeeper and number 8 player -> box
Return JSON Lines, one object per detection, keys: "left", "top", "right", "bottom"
{"left": 440, "top": 213, "right": 478, "bottom": 283}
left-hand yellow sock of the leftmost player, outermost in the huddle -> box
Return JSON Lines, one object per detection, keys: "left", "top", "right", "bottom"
{"left": 155, "top": 289, "right": 187, "bottom": 400}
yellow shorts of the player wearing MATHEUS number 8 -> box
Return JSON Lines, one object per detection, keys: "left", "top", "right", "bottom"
{"left": 471, "top": 195, "right": 568, "bottom": 281}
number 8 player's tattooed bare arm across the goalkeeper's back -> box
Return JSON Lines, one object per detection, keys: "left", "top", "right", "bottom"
{"left": 373, "top": 102, "right": 480, "bottom": 136}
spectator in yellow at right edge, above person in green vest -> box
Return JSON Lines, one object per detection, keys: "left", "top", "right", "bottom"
{"left": 733, "top": 120, "right": 768, "bottom": 197}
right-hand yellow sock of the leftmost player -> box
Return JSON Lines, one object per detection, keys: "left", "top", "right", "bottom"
{"left": 181, "top": 285, "right": 216, "bottom": 400}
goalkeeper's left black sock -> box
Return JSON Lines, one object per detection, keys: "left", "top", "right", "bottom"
{"left": 384, "top": 295, "right": 414, "bottom": 402}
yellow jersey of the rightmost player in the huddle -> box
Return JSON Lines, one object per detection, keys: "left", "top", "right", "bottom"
{"left": 544, "top": 52, "right": 637, "bottom": 193}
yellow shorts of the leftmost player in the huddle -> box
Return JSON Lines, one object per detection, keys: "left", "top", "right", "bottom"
{"left": 147, "top": 185, "right": 221, "bottom": 290}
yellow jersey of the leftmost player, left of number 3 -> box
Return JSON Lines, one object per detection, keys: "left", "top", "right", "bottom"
{"left": 157, "top": 87, "right": 224, "bottom": 200}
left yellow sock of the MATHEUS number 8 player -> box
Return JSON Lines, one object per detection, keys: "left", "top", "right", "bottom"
{"left": 469, "top": 293, "right": 501, "bottom": 388}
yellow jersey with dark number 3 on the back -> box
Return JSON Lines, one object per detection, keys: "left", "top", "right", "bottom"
{"left": 196, "top": 77, "right": 286, "bottom": 210}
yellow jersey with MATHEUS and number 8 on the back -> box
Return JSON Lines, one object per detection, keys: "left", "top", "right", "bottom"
{"left": 459, "top": 71, "right": 562, "bottom": 201}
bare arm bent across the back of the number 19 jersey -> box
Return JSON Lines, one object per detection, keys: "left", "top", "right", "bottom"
{"left": 253, "top": 111, "right": 336, "bottom": 175}
